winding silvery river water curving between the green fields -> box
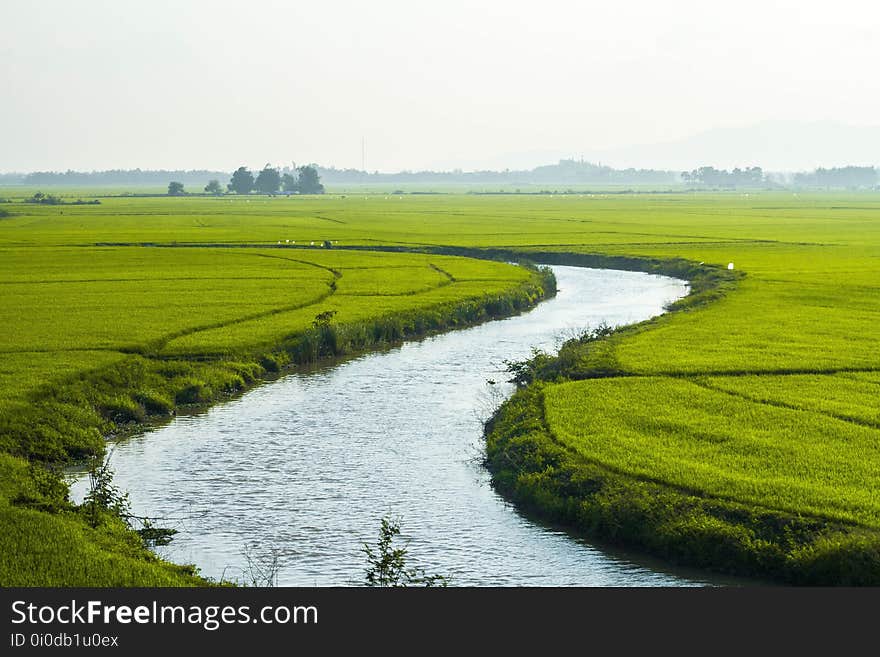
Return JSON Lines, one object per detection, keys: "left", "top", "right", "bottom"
{"left": 72, "top": 266, "right": 712, "bottom": 586}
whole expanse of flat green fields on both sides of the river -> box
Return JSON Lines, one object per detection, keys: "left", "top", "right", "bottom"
{"left": 0, "top": 193, "right": 880, "bottom": 583}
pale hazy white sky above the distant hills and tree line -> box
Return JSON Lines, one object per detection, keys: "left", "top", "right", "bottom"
{"left": 0, "top": 0, "right": 880, "bottom": 171}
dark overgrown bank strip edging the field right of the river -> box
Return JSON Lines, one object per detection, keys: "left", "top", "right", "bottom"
{"left": 484, "top": 253, "right": 880, "bottom": 586}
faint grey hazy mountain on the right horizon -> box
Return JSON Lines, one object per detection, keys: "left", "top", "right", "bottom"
{"left": 585, "top": 121, "right": 880, "bottom": 171}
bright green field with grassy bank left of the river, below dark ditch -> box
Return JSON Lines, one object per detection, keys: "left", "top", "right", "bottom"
{"left": 0, "top": 192, "right": 555, "bottom": 586}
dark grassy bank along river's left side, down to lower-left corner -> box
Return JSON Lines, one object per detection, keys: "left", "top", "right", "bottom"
{"left": 0, "top": 255, "right": 556, "bottom": 587}
